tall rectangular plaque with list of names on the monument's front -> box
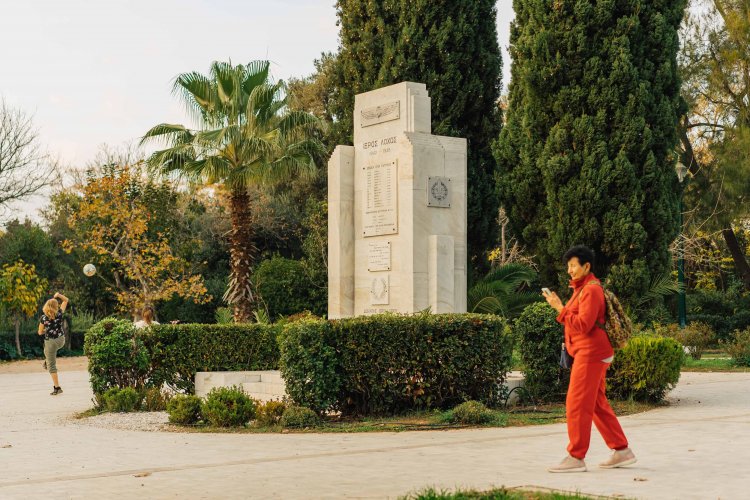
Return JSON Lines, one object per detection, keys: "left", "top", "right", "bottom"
{"left": 362, "top": 160, "right": 398, "bottom": 237}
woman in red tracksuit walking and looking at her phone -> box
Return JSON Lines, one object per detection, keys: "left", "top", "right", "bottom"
{"left": 545, "top": 246, "right": 636, "bottom": 472}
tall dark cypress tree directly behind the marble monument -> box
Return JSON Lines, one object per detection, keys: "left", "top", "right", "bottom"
{"left": 330, "top": 0, "right": 502, "bottom": 266}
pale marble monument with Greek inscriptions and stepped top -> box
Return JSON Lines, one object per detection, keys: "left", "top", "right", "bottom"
{"left": 328, "top": 82, "right": 467, "bottom": 318}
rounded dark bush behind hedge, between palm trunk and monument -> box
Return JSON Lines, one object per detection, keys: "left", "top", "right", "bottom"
{"left": 253, "top": 256, "right": 328, "bottom": 320}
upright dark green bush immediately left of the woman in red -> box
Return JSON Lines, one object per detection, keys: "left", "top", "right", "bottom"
{"left": 513, "top": 302, "right": 570, "bottom": 401}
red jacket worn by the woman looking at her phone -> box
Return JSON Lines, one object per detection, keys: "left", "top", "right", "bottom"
{"left": 557, "top": 273, "right": 614, "bottom": 362}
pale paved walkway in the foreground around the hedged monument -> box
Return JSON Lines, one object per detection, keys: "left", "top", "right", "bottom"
{"left": 0, "top": 360, "right": 750, "bottom": 499}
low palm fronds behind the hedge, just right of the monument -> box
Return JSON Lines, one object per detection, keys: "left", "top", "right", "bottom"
{"left": 468, "top": 263, "right": 541, "bottom": 318}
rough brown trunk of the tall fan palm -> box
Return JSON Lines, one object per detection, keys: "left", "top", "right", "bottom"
{"left": 224, "top": 189, "right": 255, "bottom": 323}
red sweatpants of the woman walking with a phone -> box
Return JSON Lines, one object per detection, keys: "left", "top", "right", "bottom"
{"left": 565, "top": 360, "right": 628, "bottom": 460}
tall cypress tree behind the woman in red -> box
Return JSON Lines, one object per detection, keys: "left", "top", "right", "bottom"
{"left": 495, "top": 0, "right": 686, "bottom": 298}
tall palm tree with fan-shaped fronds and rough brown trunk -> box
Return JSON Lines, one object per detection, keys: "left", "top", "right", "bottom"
{"left": 141, "top": 61, "right": 324, "bottom": 322}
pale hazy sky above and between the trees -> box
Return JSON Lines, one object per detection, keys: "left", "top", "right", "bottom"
{"left": 0, "top": 0, "right": 513, "bottom": 219}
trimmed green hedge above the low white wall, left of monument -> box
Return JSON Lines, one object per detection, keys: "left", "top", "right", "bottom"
{"left": 143, "top": 324, "right": 280, "bottom": 393}
